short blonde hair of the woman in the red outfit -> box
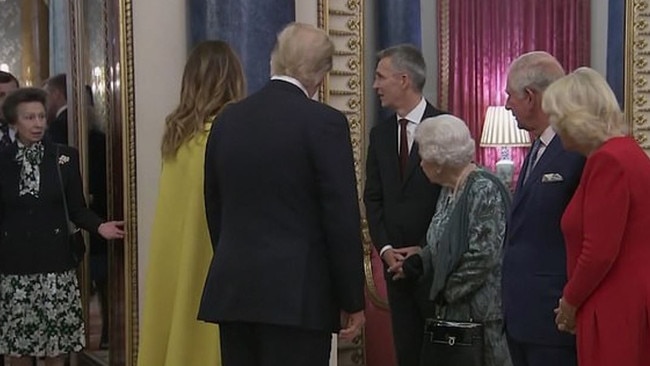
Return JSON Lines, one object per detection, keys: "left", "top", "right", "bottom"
{"left": 542, "top": 67, "right": 627, "bottom": 149}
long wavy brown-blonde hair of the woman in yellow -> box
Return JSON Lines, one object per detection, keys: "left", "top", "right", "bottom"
{"left": 161, "top": 41, "right": 245, "bottom": 158}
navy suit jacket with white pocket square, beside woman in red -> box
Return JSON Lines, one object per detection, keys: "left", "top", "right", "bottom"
{"left": 502, "top": 136, "right": 585, "bottom": 345}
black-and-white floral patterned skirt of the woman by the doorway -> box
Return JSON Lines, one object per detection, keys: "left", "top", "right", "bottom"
{"left": 0, "top": 270, "right": 85, "bottom": 357}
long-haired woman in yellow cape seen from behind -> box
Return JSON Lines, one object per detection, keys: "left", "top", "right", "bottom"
{"left": 138, "top": 41, "right": 245, "bottom": 366}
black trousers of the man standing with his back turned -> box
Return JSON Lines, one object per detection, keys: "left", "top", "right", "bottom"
{"left": 219, "top": 322, "right": 332, "bottom": 366}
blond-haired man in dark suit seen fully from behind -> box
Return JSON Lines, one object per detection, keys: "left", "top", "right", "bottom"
{"left": 199, "top": 23, "right": 365, "bottom": 366}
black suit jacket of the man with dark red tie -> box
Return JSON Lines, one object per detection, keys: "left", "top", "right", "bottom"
{"left": 364, "top": 102, "right": 443, "bottom": 260}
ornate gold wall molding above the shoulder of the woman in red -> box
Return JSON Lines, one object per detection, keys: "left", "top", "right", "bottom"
{"left": 625, "top": 0, "right": 650, "bottom": 154}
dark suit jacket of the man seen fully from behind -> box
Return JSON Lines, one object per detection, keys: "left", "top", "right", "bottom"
{"left": 199, "top": 80, "right": 364, "bottom": 331}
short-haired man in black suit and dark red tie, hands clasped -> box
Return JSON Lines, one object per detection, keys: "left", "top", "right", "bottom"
{"left": 364, "top": 44, "right": 443, "bottom": 366}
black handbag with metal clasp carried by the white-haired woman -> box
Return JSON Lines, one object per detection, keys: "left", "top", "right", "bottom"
{"left": 420, "top": 319, "right": 484, "bottom": 366}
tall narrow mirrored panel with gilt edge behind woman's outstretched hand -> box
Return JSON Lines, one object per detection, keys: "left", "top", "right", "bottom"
{"left": 71, "top": 0, "right": 138, "bottom": 365}
